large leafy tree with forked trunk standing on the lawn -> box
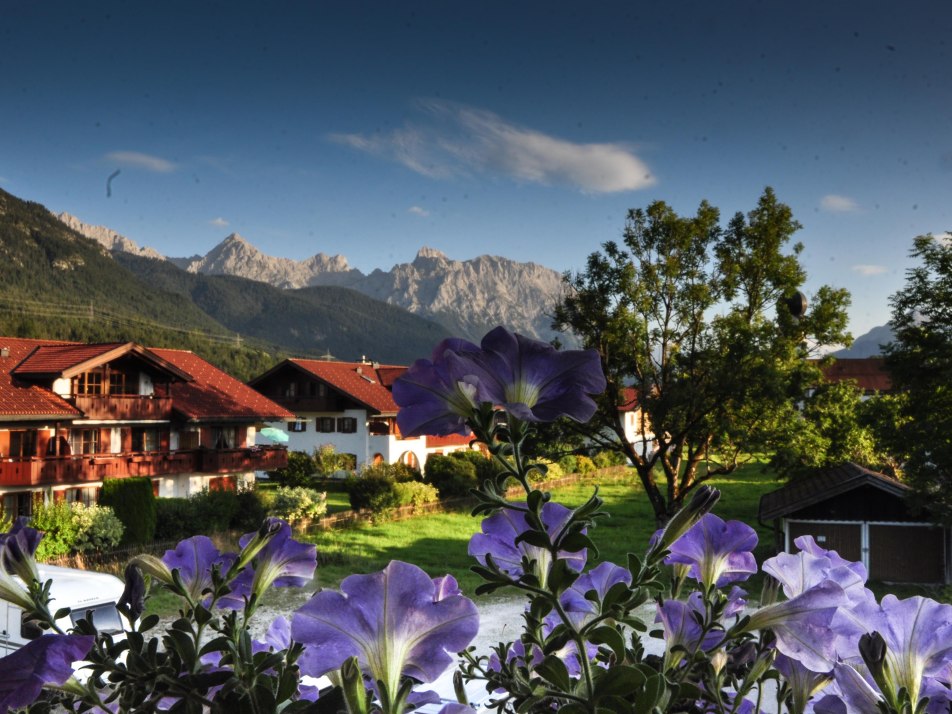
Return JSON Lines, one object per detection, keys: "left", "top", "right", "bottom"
{"left": 553, "top": 188, "right": 849, "bottom": 521}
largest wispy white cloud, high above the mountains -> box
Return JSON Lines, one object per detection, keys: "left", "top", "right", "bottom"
{"left": 330, "top": 100, "right": 656, "bottom": 193}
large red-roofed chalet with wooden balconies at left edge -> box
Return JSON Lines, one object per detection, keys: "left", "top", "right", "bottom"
{"left": 0, "top": 337, "right": 293, "bottom": 517}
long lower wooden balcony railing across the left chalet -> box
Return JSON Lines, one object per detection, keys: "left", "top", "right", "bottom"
{"left": 0, "top": 446, "right": 288, "bottom": 487}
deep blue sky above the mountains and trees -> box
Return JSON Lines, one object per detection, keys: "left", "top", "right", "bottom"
{"left": 0, "top": 0, "right": 952, "bottom": 335}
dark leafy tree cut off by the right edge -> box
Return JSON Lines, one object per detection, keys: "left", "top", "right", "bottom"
{"left": 885, "top": 235, "right": 952, "bottom": 522}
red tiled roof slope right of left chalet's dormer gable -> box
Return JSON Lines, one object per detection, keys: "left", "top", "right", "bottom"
{"left": 152, "top": 349, "right": 294, "bottom": 421}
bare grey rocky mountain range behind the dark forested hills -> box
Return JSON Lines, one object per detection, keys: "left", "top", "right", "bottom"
{"left": 57, "top": 213, "right": 564, "bottom": 341}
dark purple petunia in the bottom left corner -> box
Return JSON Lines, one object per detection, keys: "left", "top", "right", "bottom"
{"left": 0, "top": 635, "right": 94, "bottom": 712}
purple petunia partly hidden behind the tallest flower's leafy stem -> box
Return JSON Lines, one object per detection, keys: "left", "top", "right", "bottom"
{"left": 469, "top": 501, "right": 586, "bottom": 587}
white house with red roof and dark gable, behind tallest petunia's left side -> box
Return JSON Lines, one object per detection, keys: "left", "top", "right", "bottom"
{"left": 248, "top": 359, "right": 470, "bottom": 469}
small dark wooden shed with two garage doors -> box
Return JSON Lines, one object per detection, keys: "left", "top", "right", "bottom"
{"left": 759, "top": 463, "right": 952, "bottom": 583}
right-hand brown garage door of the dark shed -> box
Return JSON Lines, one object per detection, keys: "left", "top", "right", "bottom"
{"left": 869, "top": 523, "right": 945, "bottom": 583}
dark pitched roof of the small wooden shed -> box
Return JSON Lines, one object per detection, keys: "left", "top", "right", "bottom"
{"left": 758, "top": 462, "right": 910, "bottom": 521}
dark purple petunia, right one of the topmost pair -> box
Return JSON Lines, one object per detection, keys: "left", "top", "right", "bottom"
{"left": 475, "top": 327, "right": 606, "bottom": 422}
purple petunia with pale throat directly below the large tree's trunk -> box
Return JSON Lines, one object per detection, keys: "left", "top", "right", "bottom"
{"left": 665, "top": 513, "right": 757, "bottom": 587}
